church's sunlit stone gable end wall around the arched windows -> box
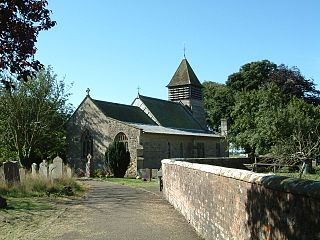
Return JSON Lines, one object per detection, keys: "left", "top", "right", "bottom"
{"left": 67, "top": 98, "right": 141, "bottom": 175}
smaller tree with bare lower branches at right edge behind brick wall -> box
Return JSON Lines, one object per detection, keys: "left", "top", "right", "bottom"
{"left": 271, "top": 98, "right": 320, "bottom": 167}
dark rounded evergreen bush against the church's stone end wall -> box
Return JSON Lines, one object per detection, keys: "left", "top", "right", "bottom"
{"left": 105, "top": 141, "right": 130, "bottom": 178}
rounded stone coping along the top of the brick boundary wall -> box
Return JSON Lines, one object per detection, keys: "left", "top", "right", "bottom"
{"left": 161, "top": 159, "right": 320, "bottom": 199}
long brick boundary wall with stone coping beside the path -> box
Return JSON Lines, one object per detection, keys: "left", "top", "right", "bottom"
{"left": 162, "top": 160, "right": 320, "bottom": 240}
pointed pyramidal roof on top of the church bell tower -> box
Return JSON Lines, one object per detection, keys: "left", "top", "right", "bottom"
{"left": 167, "top": 59, "right": 202, "bottom": 88}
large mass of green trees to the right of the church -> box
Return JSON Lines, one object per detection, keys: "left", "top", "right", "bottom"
{"left": 204, "top": 60, "right": 320, "bottom": 159}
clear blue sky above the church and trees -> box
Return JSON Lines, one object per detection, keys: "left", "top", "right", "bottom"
{"left": 37, "top": 0, "right": 320, "bottom": 107}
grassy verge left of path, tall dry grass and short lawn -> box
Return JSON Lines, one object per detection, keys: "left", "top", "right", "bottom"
{"left": 0, "top": 176, "right": 85, "bottom": 240}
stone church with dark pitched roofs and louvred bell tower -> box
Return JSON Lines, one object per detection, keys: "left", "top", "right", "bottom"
{"left": 67, "top": 59, "right": 227, "bottom": 175}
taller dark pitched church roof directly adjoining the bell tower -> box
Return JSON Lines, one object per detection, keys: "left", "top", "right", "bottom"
{"left": 139, "top": 95, "right": 202, "bottom": 130}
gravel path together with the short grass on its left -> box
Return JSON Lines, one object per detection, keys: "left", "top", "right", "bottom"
{"left": 0, "top": 178, "right": 200, "bottom": 240}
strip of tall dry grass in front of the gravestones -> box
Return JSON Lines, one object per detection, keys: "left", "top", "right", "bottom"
{"left": 0, "top": 175, "right": 84, "bottom": 198}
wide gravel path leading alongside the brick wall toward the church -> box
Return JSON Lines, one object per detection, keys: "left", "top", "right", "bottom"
{"left": 25, "top": 181, "right": 200, "bottom": 240}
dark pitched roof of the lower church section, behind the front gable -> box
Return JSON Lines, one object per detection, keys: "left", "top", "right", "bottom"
{"left": 92, "top": 99, "right": 156, "bottom": 125}
